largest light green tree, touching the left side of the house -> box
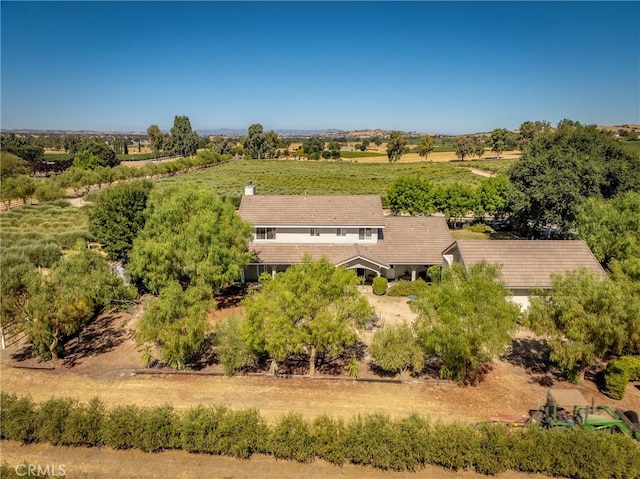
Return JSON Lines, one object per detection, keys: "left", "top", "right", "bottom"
{"left": 129, "top": 185, "right": 253, "bottom": 293}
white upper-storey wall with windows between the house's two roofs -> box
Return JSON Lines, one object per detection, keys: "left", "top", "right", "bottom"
{"left": 254, "top": 227, "right": 378, "bottom": 245}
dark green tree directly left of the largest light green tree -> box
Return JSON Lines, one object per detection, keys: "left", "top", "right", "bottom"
{"left": 89, "top": 181, "right": 152, "bottom": 260}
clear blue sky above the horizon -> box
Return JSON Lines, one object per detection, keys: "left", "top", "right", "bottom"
{"left": 0, "top": 1, "right": 640, "bottom": 134}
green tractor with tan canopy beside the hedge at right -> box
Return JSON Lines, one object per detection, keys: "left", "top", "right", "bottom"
{"left": 529, "top": 389, "right": 640, "bottom": 440}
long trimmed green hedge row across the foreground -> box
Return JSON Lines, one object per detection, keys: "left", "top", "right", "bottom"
{"left": 0, "top": 393, "right": 640, "bottom": 479}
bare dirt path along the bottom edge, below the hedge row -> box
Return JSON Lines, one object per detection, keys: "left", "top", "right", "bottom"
{"left": 0, "top": 441, "right": 545, "bottom": 479}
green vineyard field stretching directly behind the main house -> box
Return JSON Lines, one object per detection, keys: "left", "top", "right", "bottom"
{"left": 158, "top": 159, "right": 512, "bottom": 196}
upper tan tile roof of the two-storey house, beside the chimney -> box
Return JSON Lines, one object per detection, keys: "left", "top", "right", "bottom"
{"left": 238, "top": 195, "right": 383, "bottom": 227}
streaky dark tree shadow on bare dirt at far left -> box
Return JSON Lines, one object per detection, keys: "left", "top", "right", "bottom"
{"left": 63, "top": 314, "right": 133, "bottom": 368}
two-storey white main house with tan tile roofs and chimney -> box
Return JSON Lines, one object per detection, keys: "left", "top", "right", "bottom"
{"left": 238, "top": 183, "right": 453, "bottom": 281}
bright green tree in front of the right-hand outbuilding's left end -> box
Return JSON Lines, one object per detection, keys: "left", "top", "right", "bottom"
{"left": 411, "top": 263, "right": 520, "bottom": 383}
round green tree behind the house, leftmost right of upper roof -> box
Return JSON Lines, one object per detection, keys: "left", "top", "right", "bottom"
{"left": 387, "top": 176, "right": 436, "bottom": 216}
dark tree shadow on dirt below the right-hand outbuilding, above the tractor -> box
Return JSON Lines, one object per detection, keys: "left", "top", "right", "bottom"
{"left": 501, "top": 338, "right": 564, "bottom": 387}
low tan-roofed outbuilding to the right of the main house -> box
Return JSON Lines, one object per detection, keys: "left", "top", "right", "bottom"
{"left": 442, "top": 240, "right": 606, "bottom": 309}
